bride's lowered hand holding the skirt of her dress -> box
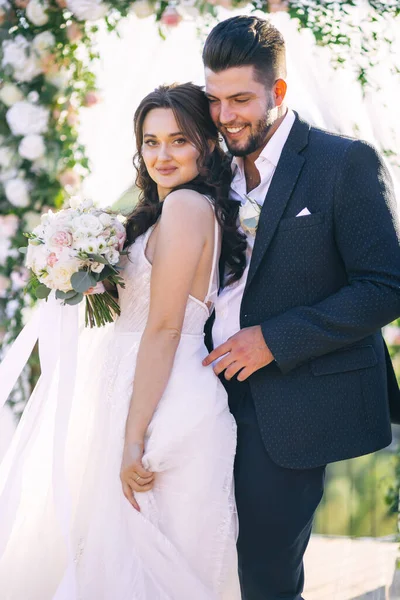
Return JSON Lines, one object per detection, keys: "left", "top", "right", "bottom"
{"left": 120, "top": 441, "right": 154, "bottom": 512}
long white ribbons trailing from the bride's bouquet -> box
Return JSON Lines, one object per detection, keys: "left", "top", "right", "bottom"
{"left": 0, "top": 293, "right": 79, "bottom": 600}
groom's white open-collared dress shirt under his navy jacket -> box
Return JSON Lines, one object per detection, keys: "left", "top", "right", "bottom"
{"left": 212, "top": 109, "right": 295, "bottom": 348}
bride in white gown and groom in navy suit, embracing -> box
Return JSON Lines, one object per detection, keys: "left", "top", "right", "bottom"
{"left": 0, "top": 16, "right": 400, "bottom": 600}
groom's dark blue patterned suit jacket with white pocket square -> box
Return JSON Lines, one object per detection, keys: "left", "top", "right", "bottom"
{"left": 209, "top": 115, "right": 400, "bottom": 469}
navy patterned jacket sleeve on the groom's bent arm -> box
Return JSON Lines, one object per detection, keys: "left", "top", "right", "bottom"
{"left": 261, "top": 141, "right": 400, "bottom": 373}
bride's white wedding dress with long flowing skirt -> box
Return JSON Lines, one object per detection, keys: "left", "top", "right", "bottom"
{"left": 0, "top": 200, "right": 240, "bottom": 600}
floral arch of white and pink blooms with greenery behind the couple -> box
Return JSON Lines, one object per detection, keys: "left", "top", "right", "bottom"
{"left": 0, "top": 0, "right": 400, "bottom": 410}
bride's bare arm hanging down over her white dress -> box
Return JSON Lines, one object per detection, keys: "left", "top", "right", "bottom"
{"left": 121, "top": 190, "right": 214, "bottom": 508}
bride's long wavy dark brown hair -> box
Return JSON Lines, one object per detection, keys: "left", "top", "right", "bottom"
{"left": 126, "top": 83, "right": 246, "bottom": 285}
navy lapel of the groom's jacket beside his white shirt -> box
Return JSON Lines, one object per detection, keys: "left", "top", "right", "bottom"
{"left": 245, "top": 115, "right": 310, "bottom": 291}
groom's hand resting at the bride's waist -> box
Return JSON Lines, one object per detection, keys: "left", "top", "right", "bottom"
{"left": 203, "top": 325, "right": 274, "bottom": 381}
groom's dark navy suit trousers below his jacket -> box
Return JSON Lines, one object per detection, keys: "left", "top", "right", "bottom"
{"left": 222, "top": 377, "right": 325, "bottom": 600}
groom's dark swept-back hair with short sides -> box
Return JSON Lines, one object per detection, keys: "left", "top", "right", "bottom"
{"left": 203, "top": 15, "right": 286, "bottom": 87}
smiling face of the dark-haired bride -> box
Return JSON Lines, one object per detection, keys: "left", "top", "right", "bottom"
{"left": 141, "top": 108, "right": 200, "bottom": 200}
